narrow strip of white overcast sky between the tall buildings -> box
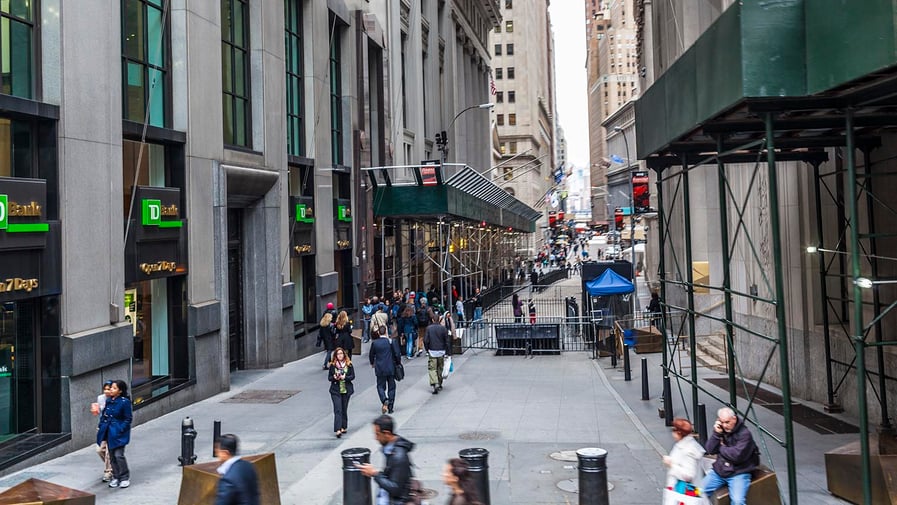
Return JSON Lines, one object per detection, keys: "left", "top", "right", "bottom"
{"left": 548, "top": 0, "right": 589, "bottom": 167}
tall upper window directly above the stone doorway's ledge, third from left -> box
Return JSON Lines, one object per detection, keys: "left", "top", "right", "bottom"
{"left": 221, "top": 0, "right": 252, "bottom": 147}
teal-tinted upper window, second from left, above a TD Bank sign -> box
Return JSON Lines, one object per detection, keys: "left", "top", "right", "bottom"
{"left": 122, "top": 0, "right": 169, "bottom": 128}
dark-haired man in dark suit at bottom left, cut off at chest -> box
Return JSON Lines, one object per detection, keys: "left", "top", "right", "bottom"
{"left": 215, "top": 433, "right": 259, "bottom": 505}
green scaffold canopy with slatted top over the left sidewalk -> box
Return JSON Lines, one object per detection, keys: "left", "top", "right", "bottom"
{"left": 364, "top": 164, "right": 542, "bottom": 233}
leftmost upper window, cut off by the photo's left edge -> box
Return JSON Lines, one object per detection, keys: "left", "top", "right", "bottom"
{"left": 0, "top": 0, "right": 37, "bottom": 98}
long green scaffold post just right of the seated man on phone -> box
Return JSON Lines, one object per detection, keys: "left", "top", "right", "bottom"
{"left": 766, "top": 112, "right": 800, "bottom": 505}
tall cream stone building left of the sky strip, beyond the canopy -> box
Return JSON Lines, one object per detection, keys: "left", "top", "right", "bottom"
{"left": 489, "top": 0, "right": 557, "bottom": 251}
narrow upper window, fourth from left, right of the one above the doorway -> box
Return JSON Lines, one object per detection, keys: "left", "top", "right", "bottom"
{"left": 283, "top": 0, "right": 305, "bottom": 156}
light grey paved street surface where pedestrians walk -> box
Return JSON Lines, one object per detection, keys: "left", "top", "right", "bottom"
{"left": 0, "top": 277, "right": 856, "bottom": 505}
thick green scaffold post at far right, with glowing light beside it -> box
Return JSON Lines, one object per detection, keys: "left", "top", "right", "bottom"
{"left": 844, "top": 108, "right": 872, "bottom": 505}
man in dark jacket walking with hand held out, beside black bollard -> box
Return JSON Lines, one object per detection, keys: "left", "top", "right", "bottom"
{"left": 355, "top": 414, "right": 420, "bottom": 505}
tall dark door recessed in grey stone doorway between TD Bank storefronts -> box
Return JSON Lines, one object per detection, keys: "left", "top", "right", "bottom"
{"left": 227, "top": 209, "right": 245, "bottom": 371}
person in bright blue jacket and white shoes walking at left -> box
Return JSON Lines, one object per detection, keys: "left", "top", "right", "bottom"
{"left": 97, "top": 380, "right": 132, "bottom": 488}
